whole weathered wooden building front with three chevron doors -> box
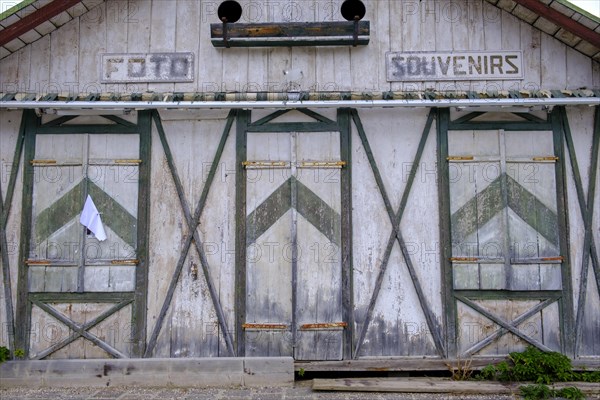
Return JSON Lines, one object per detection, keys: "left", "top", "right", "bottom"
{"left": 0, "top": 0, "right": 600, "bottom": 368}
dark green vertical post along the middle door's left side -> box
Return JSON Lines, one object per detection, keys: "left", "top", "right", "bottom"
{"left": 235, "top": 110, "right": 251, "bottom": 357}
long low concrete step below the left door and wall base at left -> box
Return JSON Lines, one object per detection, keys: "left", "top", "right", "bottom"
{"left": 0, "top": 357, "right": 294, "bottom": 388}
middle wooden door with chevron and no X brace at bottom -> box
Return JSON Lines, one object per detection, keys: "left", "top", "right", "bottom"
{"left": 244, "top": 132, "right": 345, "bottom": 360}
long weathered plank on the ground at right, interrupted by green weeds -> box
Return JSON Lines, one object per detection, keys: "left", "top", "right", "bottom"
{"left": 313, "top": 378, "right": 600, "bottom": 395}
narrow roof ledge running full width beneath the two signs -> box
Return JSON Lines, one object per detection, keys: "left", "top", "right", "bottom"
{"left": 0, "top": 90, "right": 600, "bottom": 111}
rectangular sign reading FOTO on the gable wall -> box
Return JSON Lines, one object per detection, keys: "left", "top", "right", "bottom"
{"left": 100, "top": 53, "right": 194, "bottom": 83}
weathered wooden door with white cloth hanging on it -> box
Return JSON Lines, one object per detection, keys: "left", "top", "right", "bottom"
{"left": 26, "top": 134, "right": 139, "bottom": 358}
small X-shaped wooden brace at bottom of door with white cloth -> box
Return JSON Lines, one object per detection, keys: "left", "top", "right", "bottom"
{"left": 31, "top": 299, "right": 133, "bottom": 360}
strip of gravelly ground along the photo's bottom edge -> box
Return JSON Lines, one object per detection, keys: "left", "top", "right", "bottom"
{"left": 0, "top": 381, "right": 515, "bottom": 400}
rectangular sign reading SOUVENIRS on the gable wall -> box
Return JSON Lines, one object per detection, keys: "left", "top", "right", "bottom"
{"left": 386, "top": 51, "right": 523, "bottom": 82}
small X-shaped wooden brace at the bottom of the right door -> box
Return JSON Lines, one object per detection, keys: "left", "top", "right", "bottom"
{"left": 454, "top": 295, "right": 556, "bottom": 354}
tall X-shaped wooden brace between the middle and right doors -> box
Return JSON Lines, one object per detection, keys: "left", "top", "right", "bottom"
{"left": 352, "top": 110, "right": 445, "bottom": 358}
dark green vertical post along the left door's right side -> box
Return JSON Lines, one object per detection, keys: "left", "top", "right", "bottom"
{"left": 131, "top": 111, "right": 152, "bottom": 357}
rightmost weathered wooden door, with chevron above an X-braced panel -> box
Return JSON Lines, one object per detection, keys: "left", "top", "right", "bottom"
{"left": 448, "top": 130, "right": 563, "bottom": 356}
